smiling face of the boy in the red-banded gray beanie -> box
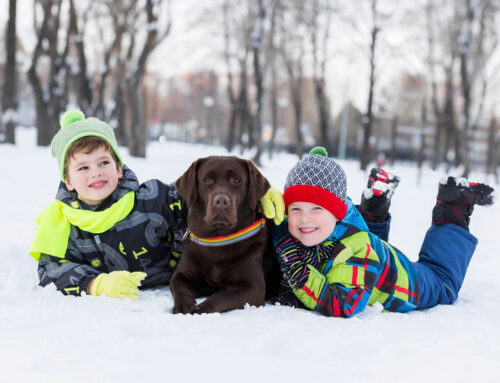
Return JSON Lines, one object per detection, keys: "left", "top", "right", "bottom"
{"left": 288, "top": 202, "right": 338, "bottom": 246}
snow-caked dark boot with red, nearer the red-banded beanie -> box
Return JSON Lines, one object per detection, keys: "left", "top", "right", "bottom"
{"left": 359, "top": 168, "right": 400, "bottom": 222}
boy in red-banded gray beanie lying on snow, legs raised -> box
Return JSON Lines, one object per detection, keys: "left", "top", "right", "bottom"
{"left": 275, "top": 148, "right": 493, "bottom": 317}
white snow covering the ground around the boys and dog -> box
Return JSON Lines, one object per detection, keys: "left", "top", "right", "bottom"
{"left": 0, "top": 129, "right": 500, "bottom": 383}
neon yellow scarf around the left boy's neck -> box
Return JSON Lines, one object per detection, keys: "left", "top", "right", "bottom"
{"left": 30, "top": 191, "right": 135, "bottom": 261}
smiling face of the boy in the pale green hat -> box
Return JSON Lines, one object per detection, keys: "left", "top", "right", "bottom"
{"left": 66, "top": 146, "right": 123, "bottom": 205}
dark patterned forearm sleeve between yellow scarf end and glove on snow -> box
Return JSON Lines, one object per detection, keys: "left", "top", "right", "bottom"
{"left": 38, "top": 253, "right": 100, "bottom": 295}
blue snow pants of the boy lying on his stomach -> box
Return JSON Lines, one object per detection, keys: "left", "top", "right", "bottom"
{"left": 366, "top": 219, "right": 477, "bottom": 310}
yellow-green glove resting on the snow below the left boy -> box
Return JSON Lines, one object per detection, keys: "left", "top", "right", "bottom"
{"left": 89, "top": 271, "right": 147, "bottom": 300}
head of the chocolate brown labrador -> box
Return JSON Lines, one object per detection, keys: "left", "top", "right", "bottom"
{"left": 175, "top": 156, "right": 270, "bottom": 229}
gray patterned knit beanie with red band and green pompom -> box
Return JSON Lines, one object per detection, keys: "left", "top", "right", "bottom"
{"left": 283, "top": 147, "right": 347, "bottom": 220}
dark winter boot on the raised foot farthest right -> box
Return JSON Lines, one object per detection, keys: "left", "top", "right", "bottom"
{"left": 432, "top": 177, "right": 493, "bottom": 231}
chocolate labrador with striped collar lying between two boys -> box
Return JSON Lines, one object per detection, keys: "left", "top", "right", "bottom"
{"left": 170, "top": 156, "right": 280, "bottom": 314}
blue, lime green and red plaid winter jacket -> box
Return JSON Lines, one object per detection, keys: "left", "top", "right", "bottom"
{"left": 273, "top": 198, "right": 419, "bottom": 317}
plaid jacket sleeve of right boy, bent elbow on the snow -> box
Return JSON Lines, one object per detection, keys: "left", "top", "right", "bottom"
{"left": 293, "top": 243, "right": 380, "bottom": 317}
